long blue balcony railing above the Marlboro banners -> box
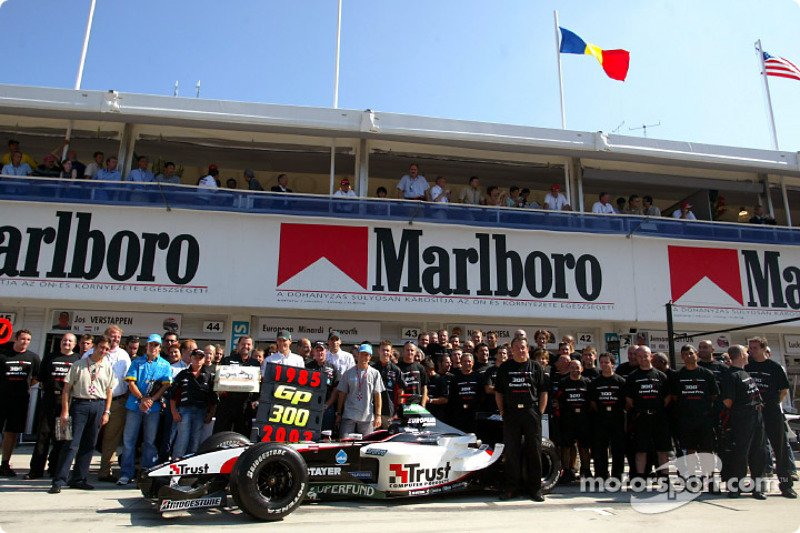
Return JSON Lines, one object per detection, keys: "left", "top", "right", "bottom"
{"left": 0, "top": 176, "right": 800, "bottom": 245}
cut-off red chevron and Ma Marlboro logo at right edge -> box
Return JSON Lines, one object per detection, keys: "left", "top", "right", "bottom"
{"left": 668, "top": 246, "right": 800, "bottom": 309}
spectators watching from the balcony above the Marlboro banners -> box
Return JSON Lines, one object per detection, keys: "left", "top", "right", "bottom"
{"left": 0, "top": 139, "right": 776, "bottom": 220}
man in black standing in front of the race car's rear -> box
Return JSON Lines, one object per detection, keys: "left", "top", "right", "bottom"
{"left": 494, "top": 337, "right": 547, "bottom": 502}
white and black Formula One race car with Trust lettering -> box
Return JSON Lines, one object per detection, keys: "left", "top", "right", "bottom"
{"left": 139, "top": 404, "right": 561, "bottom": 521}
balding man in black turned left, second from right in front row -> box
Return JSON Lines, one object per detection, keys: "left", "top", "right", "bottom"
{"left": 721, "top": 345, "right": 767, "bottom": 500}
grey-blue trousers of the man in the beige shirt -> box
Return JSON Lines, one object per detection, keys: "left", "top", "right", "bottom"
{"left": 53, "top": 398, "right": 106, "bottom": 487}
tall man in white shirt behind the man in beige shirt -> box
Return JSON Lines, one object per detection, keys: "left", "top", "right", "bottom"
{"left": 82, "top": 326, "right": 131, "bottom": 483}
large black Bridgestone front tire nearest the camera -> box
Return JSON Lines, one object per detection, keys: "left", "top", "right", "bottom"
{"left": 230, "top": 442, "right": 308, "bottom": 522}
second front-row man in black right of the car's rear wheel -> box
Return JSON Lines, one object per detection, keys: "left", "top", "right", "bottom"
{"left": 589, "top": 353, "right": 625, "bottom": 480}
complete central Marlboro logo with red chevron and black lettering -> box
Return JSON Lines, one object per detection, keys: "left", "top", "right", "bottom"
{"left": 277, "top": 223, "right": 603, "bottom": 302}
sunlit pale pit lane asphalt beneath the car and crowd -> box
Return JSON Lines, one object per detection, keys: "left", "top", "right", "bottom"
{"left": 0, "top": 446, "right": 800, "bottom": 533}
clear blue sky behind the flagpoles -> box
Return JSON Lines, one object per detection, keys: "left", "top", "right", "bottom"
{"left": 0, "top": 0, "right": 800, "bottom": 151}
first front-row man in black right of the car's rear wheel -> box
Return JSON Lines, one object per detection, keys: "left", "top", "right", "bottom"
{"left": 556, "top": 359, "right": 592, "bottom": 482}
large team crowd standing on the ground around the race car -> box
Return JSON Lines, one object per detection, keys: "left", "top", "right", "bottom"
{"left": 0, "top": 326, "right": 797, "bottom": 501}
